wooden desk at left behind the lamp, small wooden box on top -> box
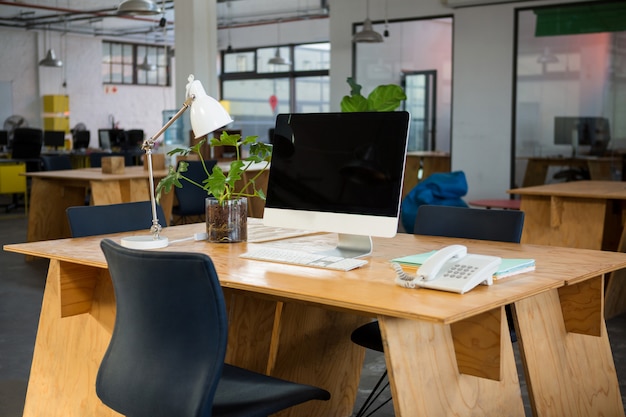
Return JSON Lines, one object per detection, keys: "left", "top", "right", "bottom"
{"left": 26, "top": 166, "right": 172, "bottom": 242}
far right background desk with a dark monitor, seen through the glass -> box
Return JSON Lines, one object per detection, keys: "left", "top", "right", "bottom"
{"left": 520, "top": 156, "right": 622, "bottom": 187}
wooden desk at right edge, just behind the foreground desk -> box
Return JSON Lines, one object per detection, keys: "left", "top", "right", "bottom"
{"left": 508, "top": 181, "right": 626, "bottom": 318}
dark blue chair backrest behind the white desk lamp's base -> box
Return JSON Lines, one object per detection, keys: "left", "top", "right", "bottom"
{"left": 66, "top": 201, "right": 167, "bottom": 237}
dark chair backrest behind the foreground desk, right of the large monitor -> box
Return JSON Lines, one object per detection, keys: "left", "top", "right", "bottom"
{"left": 413, "top": 205, "right": 524, "bottom": 243}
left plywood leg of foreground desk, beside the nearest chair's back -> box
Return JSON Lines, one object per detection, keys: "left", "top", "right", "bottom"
{"left": 23, "top": 260, "right": 120, "bottom": 417}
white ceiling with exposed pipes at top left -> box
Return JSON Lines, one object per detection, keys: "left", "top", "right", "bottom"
{"left": 0, "top": 0, "right": 329, "bottom": 44}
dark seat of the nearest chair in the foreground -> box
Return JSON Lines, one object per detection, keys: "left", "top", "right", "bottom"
{"left": 212, "top": 364, "right": 330, "bottom": 417}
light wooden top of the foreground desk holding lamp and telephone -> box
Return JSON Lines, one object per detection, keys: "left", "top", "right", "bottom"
{"left": 5, "top": 219, "right": 626, "bottom": 323}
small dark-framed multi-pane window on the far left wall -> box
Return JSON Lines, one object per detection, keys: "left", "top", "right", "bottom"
{"left": 102, "top": 41, "right": 170, "bottom": 86}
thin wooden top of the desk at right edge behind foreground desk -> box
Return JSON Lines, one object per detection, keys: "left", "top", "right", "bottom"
{"left": 507, "top": 181, "right": 626, "bottom": 200}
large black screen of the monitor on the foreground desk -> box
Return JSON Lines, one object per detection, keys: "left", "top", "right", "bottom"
{"left": 266, "top": 111, "right": 409, "bottom": 218}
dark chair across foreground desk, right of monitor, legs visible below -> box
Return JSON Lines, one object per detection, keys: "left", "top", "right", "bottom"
{"left": 350, "top": 205, "right": 524, "bottom": 417}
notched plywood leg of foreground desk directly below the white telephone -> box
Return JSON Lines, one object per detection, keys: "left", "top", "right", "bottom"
{"left": 379, "top": 317, "right": 524, "bottom": 417}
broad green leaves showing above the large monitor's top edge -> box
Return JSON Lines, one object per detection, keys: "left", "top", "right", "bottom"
{"left": 341, "top": 77, "right": 406, "bottom": 113}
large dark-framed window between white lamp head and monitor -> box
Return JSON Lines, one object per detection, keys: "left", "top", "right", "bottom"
{"left": 221, "top": 42, "right": 330, "bottom": 142}
